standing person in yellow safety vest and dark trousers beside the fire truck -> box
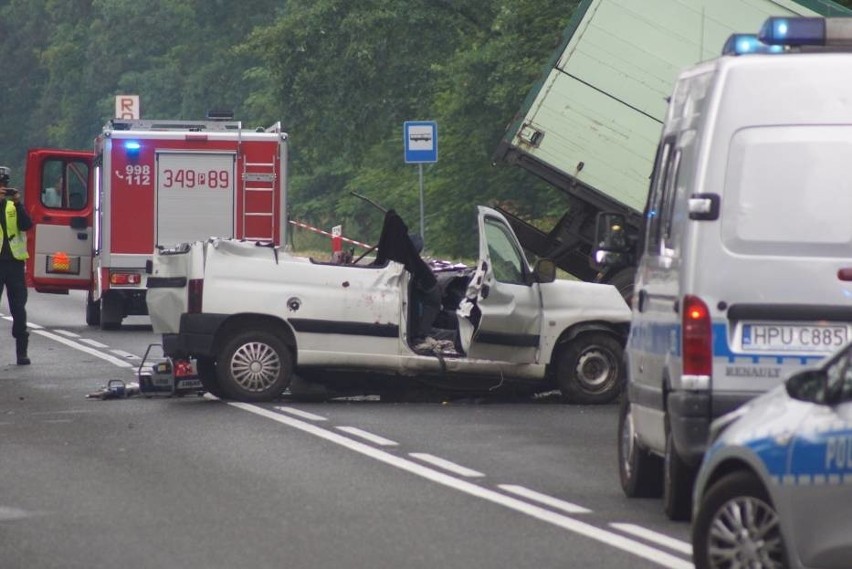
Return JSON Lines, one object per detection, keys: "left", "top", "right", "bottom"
{"left": 0, "top": 166, "right": 33, "bottom": 365}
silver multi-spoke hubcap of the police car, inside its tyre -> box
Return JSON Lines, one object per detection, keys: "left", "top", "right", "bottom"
{"left": 707, "top": 496, "right": 784, "bottom": 569}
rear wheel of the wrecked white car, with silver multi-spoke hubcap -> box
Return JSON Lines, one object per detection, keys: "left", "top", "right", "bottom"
{"left": 216, "top": 331, "right": 293, "bottom": 403}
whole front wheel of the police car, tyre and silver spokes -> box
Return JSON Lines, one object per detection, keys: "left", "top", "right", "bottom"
{"left": 692, "top": 471, "right": 789, "bottom": 569}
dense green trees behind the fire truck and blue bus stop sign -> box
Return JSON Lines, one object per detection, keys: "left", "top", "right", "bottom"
{"left": 10, "top": 0, "right": 852, "bottom": 257}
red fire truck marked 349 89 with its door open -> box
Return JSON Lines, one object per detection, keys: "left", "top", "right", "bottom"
{"left": 24, "top": 119, "right": 287, "bottom": 329}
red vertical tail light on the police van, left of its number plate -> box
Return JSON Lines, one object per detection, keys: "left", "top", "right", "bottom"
{"left": 681, "top": 295, "right": 713, "bottom": 389}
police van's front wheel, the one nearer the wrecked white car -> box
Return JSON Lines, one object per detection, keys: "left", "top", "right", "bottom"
{"left": 618, "top": 397, "right": 663, "bottom": 498}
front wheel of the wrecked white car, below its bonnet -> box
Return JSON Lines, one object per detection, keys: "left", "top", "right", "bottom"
{"left": 556, "top": 333, "right": 623, "bottom": 404}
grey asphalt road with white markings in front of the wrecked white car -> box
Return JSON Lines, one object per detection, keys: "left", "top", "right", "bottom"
{"left": 0, "top": 293, "right": 691, "bottom": 569}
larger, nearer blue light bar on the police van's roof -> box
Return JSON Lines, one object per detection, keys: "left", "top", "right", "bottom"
{"left": 758, "top": 17, "right": 852, "bottom": 46}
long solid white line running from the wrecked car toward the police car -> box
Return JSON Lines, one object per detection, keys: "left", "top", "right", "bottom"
{"left": 231, "top": 402, "right": 694, "bottom": 569}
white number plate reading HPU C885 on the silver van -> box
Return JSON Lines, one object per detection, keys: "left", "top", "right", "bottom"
{"left": 742, "top": 323, "right": 849, "bottom": 352}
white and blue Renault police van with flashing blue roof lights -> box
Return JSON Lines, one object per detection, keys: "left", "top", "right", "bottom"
{"left": 599, "top": 18, "right": 852, "bottom": 519}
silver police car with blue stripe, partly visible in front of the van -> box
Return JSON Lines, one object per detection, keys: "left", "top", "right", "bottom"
{"left": 692, "top": 343, "right": 852, "bottom": 569}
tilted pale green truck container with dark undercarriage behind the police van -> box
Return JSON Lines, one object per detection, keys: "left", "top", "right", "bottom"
{"left": 494, "top": 0, "right": 852, "bottom": 297}
